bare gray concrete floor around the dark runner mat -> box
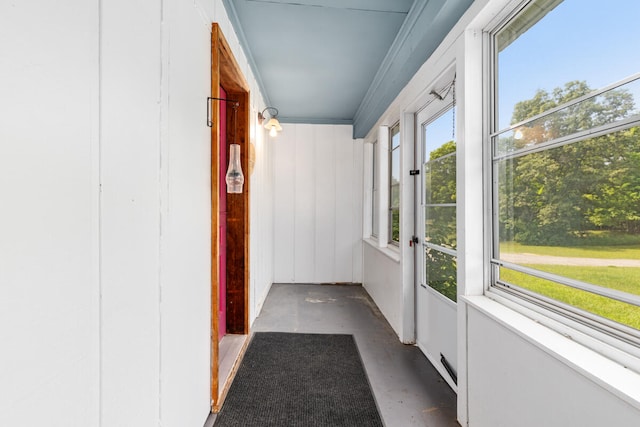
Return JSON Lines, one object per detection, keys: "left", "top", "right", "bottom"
{"left": 212, "top": 284, "right": 459, "bottom": 427}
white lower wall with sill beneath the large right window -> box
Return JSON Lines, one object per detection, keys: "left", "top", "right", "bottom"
{"left": 465, "top": 297, "right": 640, "bottom": 427}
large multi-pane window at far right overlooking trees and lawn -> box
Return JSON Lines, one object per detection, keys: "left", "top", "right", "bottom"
{"left": 490, "top": 0, "right": 640, "bottom": 346}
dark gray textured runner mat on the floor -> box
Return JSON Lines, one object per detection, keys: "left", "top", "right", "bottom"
{"left": 214, "top": 332, "right": 383, "bottom": 427}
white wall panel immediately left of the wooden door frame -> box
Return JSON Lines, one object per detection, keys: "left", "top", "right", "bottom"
{"left": 160, "top": 0, "right": 211, "bottom": 427}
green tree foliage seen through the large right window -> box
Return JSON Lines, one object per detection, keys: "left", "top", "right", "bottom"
{"left": 497, "top": 81, "right": 640, "bottom": 245}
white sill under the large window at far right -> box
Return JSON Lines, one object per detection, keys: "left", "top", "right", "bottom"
{"left": 459, "top": 296, "right": 640, "bottom": 409}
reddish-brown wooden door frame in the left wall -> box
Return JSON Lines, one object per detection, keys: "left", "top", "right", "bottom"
{"left": 210, "top": 23, "right": 251, "bottom": 410}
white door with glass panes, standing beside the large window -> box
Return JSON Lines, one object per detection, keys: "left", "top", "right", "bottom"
{"left": 416, "top": 88, "right": 457, "bottom": 391}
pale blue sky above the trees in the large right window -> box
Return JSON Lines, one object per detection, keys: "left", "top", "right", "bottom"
{"left": 498, "top": 0, "right": 640, "bottom": 129}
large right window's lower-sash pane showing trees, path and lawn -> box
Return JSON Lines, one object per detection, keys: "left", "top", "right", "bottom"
{"left": 494, "top": 127, "right": 640, "bottom": 330}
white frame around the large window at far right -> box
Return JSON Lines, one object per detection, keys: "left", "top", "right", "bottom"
{"left": 483, "top": 0, "right": 640, "bottom": 360}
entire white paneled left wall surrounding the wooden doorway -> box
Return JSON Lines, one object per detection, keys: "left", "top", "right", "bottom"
{"left": 0, "top": 0, "right": 273, "bottom": 427}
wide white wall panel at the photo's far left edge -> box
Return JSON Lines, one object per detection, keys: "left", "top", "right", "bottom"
{"left": 0, "top": 0, "right": 99, "bottom": 427}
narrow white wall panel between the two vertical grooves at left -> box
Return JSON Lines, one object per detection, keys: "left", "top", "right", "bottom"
{"left": 101, "top": 0, "right": 162, "bottom": 427}
